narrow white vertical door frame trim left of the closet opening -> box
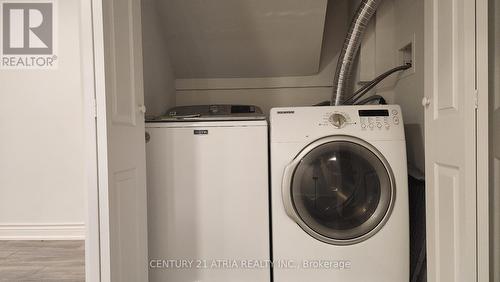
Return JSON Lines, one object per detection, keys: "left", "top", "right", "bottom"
{"left": 80, "top": 0, "right": 107, "bottom": 282}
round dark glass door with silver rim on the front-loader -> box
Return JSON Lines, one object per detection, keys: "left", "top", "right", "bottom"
{"left": 283, "top": 136, "right": 396, "bottom": 245}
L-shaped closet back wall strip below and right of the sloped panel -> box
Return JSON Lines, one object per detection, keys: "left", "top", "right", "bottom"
{"left": 176, "top": 0, "right": 349, "bottom": 113}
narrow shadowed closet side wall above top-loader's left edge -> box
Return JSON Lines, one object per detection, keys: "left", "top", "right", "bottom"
{"left": 142, "top": 0, "right": 175, "bottom": 116}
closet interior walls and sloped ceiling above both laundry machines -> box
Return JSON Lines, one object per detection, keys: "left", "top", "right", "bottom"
{"left": 142, "top": 0, "right": 424, "bottom": 175}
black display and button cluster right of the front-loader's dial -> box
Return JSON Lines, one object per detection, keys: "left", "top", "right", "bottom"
{"left": 359, "top": 109, "right": 400, "bottom": 130}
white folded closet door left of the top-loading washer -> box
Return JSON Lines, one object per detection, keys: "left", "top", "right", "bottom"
{"left": 93, "top": 0, "right": 148, "bottom": 282}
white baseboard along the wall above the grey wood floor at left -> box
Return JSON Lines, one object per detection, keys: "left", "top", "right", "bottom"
{"left": 0, "top": 223, "right": 85, "bottom": 240}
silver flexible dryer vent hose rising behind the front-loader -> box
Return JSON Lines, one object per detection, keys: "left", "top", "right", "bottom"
{"left": 330, "top": 0, "right": 382, "bottom": 106}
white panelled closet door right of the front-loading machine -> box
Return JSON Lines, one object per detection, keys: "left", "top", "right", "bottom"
{"left": 422, "top": 0, "right": 477, "bottom": 282}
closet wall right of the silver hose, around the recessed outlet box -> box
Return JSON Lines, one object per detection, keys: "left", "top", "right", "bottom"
{"left": 357, "top": 0, "right": 425, "bottom": 176}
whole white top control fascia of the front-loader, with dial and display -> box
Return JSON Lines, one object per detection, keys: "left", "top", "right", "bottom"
{"left": 270, "top": 105, "right": 404, "bottom": 142}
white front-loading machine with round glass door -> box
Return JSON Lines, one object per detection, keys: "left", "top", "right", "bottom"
{"left": 270, "top": 105, "right": 409, "bottom": 282}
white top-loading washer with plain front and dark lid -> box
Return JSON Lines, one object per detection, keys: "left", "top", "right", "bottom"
{"left": 146, "top": 105, "right": 271, "bottom": 282}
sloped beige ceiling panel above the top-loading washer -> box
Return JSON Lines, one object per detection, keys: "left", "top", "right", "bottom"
{"left": 158, "top": 0, "right": 328, "bottom": 78}
